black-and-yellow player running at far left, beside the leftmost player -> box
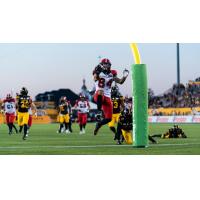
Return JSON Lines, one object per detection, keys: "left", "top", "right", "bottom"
{"left": 17, "top": 87, "right": 32, "bottom": 140}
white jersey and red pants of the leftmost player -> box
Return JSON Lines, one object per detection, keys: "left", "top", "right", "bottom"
{"left": 3, "top": 98, "right": 16, "bottom": 124}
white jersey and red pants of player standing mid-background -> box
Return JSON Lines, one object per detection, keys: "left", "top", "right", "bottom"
{"left": 75, "top": 100, "right": 90, "bottom": 125}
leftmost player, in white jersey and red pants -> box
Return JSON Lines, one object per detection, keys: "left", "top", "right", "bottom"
{"left": 2, "top": 94, "right": 18, "bottom": 135}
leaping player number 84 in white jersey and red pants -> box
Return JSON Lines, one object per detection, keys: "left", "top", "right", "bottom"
{"left": 93, "top": 58, "right": 129, "bottom": 135}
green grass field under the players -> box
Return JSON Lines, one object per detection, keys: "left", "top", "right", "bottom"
{"left": 0, "top": 124, "right": 200, "bottom": 155}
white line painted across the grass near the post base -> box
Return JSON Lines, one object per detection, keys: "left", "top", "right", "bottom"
{"left": 0, "top": 143, "right": 200, "bottom": 149}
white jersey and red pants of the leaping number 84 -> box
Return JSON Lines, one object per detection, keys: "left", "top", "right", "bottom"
{"left": 94, "top": 70, "right": 117, "bottom": 119}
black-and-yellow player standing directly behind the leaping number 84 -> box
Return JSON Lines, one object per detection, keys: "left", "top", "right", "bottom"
{"left": 108, "top": 85, "right": 124, "bottom": 140}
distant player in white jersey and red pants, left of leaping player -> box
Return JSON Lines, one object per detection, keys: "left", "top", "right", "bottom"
{"left": 74, "top": 94, "right": 90, "bottom": 134}
